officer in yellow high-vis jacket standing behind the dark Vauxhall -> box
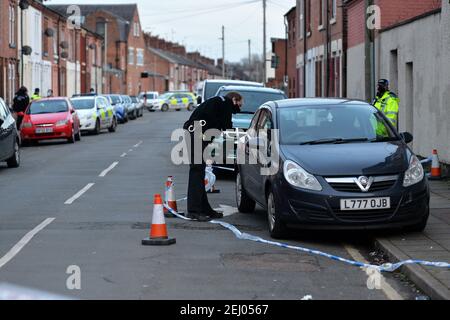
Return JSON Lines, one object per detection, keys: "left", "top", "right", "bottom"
{"left": 373, "top": 79, "right": 400, "bottom": 129}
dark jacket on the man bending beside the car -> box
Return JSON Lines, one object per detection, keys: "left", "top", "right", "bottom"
{"left": 183, "top": 97, "right": 234, "bottom": 132}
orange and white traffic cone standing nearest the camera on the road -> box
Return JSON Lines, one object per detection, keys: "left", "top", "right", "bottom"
{"left": 142, "top": 194, "right": 176, "bottom": 246}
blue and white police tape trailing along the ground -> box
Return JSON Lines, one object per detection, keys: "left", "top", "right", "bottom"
{"left": 165, "top": 205, "right": 450, "bottom": 272}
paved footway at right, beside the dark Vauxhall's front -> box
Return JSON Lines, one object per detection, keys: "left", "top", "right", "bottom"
{"left": 376, "top": 180, "right": 450, "bottom": 300}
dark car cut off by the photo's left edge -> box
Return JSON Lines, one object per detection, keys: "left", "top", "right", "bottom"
{"left": 0, "top": 98, "right": 21, "bottom": 168}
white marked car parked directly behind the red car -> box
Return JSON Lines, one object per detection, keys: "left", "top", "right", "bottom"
{"left": 71, "top": 96, "right": 117, "bottom": 134}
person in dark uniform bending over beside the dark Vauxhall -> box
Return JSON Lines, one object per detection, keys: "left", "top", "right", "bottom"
{"left": 183, "top": 92, "right": 243, "bottom": 222}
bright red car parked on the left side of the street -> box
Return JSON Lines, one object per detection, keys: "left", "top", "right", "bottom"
{"left": 20, "top": 98, "right": 81, "bottom": 143}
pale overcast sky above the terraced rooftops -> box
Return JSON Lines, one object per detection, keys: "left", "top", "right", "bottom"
{"left": 47, "top": 0, "right": 296, "bottom": 62}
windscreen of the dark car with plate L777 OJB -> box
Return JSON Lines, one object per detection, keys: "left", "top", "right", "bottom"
{"left": 279, "top": 105, "right": 398, "bottom": 145}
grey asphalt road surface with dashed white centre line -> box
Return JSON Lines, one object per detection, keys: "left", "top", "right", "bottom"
{"left": 0, "top": 112, "right": 426, "bottom": 300}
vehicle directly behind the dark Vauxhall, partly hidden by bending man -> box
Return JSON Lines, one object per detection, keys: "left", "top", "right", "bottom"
{"left": 211, "top": 86, "right": 287, "bottom": 167}
